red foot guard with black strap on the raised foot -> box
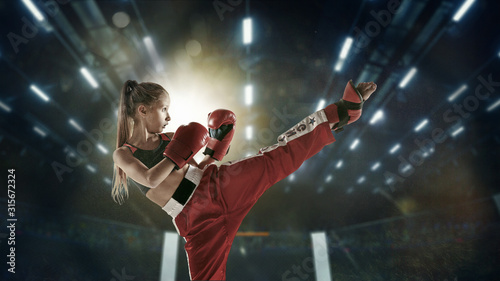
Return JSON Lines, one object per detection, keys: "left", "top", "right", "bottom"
{"left": 325, "top": 80, "right": 364, "bottom": 132}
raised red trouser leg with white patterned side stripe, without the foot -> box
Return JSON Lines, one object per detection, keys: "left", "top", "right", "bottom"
{"left": 219, "top": 110, "right": 335, "bottom": 212}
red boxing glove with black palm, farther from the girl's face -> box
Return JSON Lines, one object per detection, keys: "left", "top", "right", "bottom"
{"left": 203, "top": 109, "right": 236, "bottom": 161}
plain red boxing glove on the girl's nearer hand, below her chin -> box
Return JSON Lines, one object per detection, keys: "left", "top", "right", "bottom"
{"left": 163, "top": 122, "right": 208, "bottom": 168}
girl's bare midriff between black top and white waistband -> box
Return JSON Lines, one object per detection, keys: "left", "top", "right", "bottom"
{"left": 146, "top": 165, "right": 189, "bottom": 207}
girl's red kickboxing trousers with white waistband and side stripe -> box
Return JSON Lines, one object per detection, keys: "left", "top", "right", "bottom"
{"left": 164, "top": 110, "right": 335, "bottom": 280}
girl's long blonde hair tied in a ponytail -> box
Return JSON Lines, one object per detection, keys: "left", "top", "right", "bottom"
{"left": 111, "top": 80, "right": 168, "bottom": 204}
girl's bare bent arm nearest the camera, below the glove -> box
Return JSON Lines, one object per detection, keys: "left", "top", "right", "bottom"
{"left": 113, "top": 147, "right": 175, "bottom": 188}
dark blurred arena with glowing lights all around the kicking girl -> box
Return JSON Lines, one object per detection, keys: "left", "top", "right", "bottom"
{"left": 0, "top": 0, "right": 500, "bottom": 281}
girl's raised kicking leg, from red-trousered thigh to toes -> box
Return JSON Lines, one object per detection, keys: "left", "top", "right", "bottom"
{"left": 220, "top": 81, "right": 377, "bottom": 211}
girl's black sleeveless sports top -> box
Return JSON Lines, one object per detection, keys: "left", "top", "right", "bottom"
{"left": 123, "top": 133, "right": 170, "bottom": 195}
